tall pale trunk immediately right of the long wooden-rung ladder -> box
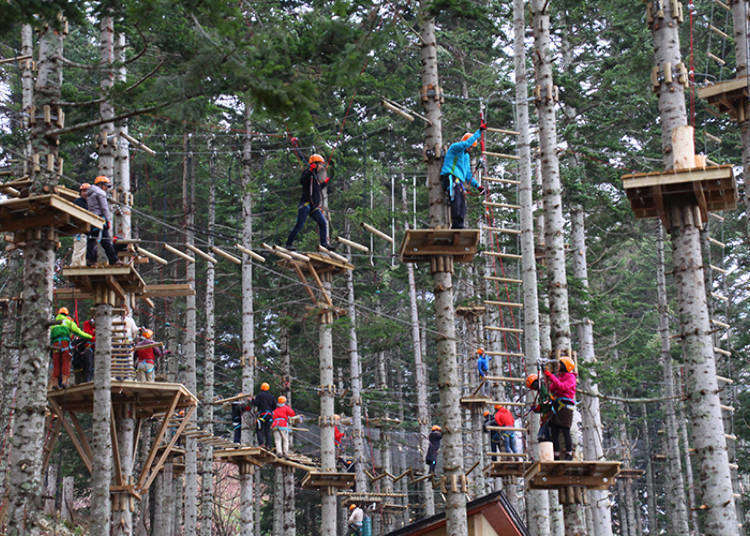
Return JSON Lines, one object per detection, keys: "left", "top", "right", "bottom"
{"left": 516, "top": 0, "right": 550, "bottom": 536}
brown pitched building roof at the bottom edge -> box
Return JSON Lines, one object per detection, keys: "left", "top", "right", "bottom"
{"left": 386, "top": 491, "right": 529, "bottom": 536}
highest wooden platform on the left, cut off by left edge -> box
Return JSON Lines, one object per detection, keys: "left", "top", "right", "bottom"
{"left": 0, "top": 194, "right": 104, "bottom": 234}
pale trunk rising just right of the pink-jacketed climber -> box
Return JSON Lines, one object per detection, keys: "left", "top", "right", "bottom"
{"left": 570, "top": 205, "right": 612, "bottom": 536}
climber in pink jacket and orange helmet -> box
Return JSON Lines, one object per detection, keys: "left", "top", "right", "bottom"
{"left": 544, "top": 357, "right": 578, "bottom": 460}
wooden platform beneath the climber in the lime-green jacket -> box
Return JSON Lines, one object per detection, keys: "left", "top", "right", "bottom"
{"left": 47, "top": 380, "right": 198, "bottom": 418}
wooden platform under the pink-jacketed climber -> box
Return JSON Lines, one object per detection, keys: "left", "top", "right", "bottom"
{"left": 524, "top": 461, "right": 620, "bottom": 489}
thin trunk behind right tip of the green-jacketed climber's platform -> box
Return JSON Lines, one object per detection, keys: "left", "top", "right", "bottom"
{"left": 182, "top": 133, "right": 198, "bottom": 536}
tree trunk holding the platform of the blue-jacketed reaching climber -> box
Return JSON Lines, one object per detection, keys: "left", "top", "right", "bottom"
{"left": 421, "top": 2, "right": 468, "bottom": 536}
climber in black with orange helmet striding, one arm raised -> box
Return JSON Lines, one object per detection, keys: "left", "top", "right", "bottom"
{"left": 286, "top": 138, "right": 333, "bottom": 251}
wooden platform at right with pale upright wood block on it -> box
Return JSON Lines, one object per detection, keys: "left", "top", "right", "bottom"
{"left": 622, "top": 165, "right": 737, "bottom": 223}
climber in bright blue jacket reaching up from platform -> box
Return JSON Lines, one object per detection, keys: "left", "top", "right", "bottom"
{"left": 440, "top": 121, "right": 487, "bottom": 229}
